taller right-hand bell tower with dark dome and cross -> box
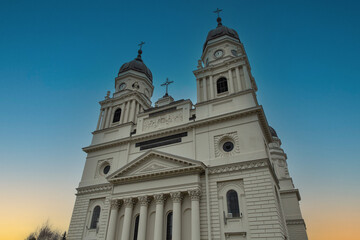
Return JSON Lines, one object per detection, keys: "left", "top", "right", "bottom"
{"left": 193, "top": 9, "right": 258, "bottom": 120}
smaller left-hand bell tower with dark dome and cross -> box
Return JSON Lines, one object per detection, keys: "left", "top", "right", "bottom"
{"left": 96, "top": 42, "right": 154, "bottom": 130}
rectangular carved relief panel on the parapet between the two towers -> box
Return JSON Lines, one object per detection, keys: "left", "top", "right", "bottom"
{"left": 143, "top": 109, "right": 183, "bottom": 131}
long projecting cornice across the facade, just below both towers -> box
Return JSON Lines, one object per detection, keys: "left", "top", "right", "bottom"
{"left": 83, "top": 105, "right": 271, "bottom": 153}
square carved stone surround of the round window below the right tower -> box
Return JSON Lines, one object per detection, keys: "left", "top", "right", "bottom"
{"left": 214, "top": 132, "right": 240, "bottom": 158}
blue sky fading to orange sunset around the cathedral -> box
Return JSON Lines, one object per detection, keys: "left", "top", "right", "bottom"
{"left": 0, "top": 0, "right": 360, "bottom": 240}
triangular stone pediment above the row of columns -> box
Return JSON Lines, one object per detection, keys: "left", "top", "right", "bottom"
{"left": 107, "top": 150, "right": 205, "bottom": 183}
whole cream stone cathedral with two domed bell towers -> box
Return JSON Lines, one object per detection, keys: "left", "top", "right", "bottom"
{"left": 68, "top": 10, "right": 307, "bottom": 240}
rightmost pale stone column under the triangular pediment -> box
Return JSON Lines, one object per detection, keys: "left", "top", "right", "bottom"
{"left": 188, "top": 189, "right": 201, "bottom": 240}
